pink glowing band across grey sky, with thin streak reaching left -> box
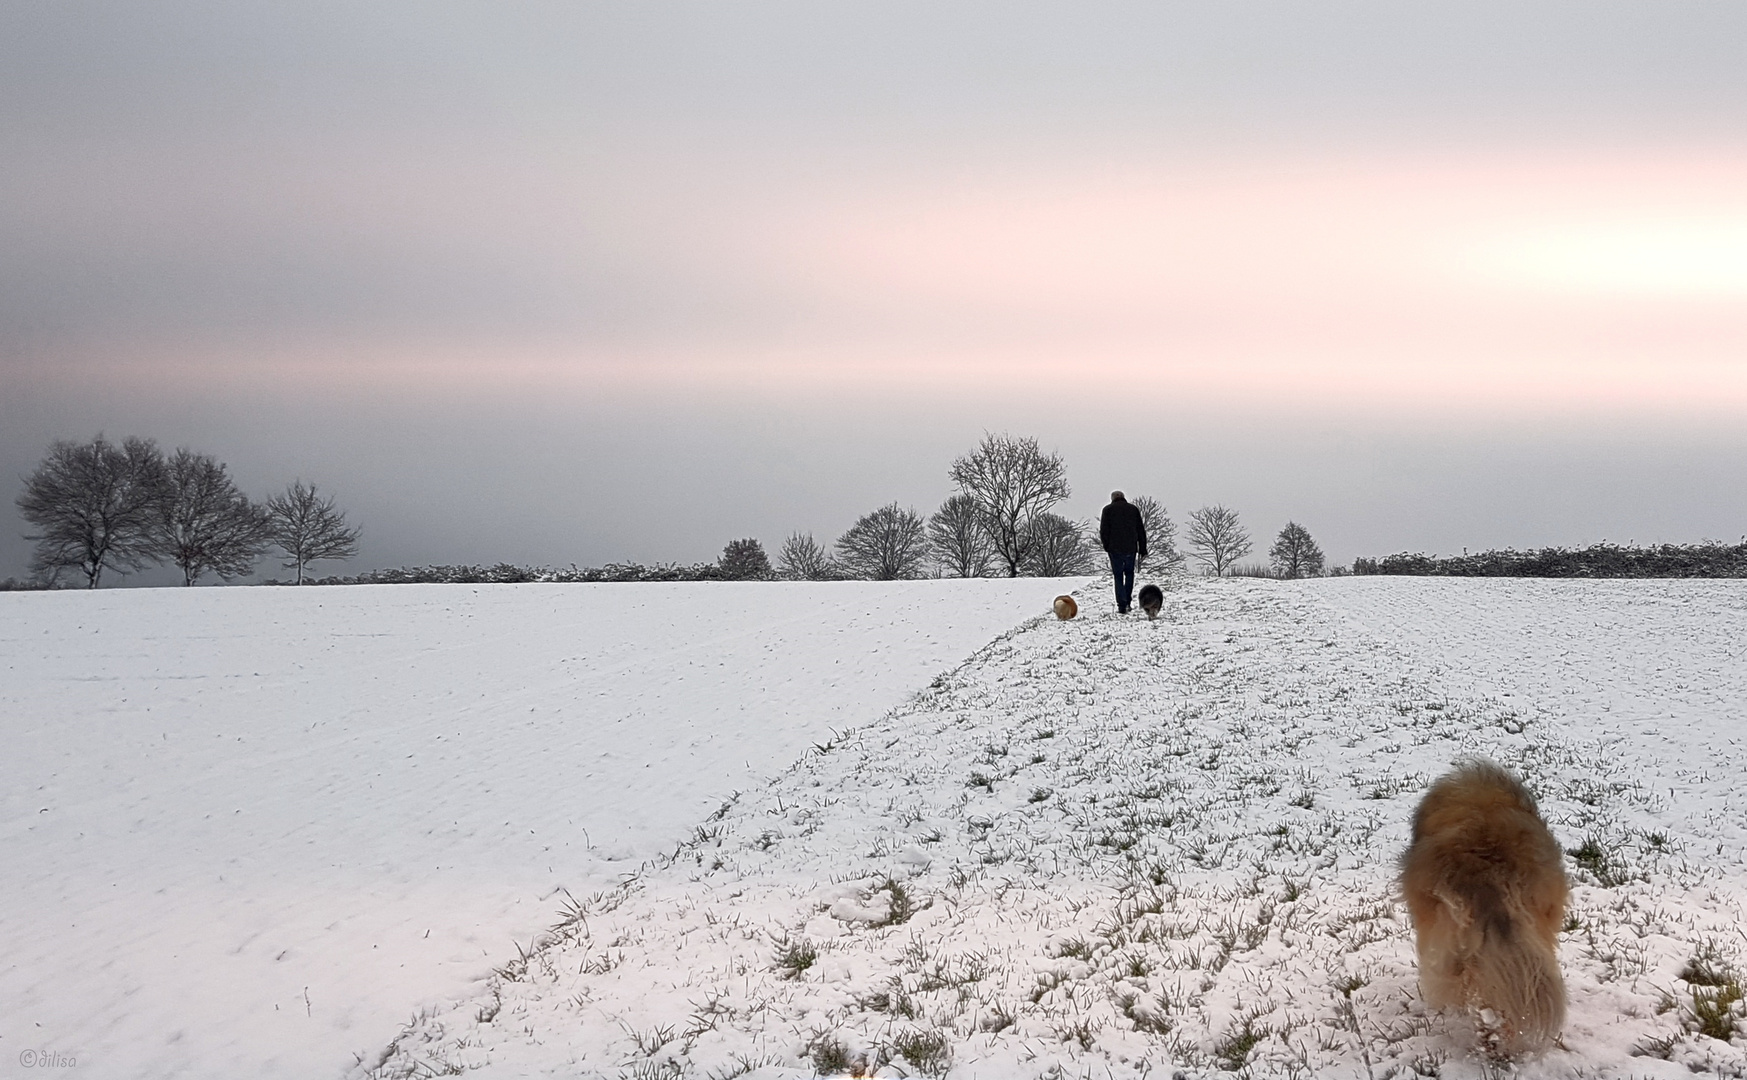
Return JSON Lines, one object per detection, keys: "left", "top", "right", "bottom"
{"left": 30, "top": 149, "right": 1747, "bottom": 412}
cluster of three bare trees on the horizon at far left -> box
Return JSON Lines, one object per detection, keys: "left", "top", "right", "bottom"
{"left": 17, "top": 435, "right": 358, "bottom": 589}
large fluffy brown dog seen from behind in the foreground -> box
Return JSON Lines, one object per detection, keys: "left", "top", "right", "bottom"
{"left": 1401, "top": 758, "right": 1567, "bottom": 1057}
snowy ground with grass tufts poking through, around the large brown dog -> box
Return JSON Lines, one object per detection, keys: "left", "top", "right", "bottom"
{"left": 358, "top": 578, "right": 1747, "bottom": 1080}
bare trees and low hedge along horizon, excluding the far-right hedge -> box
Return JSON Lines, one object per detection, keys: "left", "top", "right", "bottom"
{"left": 6, "top": 426, "right": 1324, "bottom": 589}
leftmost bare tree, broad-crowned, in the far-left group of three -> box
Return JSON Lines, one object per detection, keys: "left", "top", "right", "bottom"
{"left": 17, "top": 435, "right": 164, "bottom": 589}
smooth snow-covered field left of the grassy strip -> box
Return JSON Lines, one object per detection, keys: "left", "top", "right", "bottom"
{"left": 0, "top": 580, "right": 1067, "bottom": 1078}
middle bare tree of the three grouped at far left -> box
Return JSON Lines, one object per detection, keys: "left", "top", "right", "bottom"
{"left": 154, "top": 447, "right": 273, "bottom": 585}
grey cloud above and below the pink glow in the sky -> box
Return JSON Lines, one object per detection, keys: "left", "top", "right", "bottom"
{"left": 0, "top": 0, "right": 1747, "bottom": 577}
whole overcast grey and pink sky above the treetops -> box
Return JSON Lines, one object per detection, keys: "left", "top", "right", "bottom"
{"left": 0, "top": 0, "right": 1747, "bottom": 582}
